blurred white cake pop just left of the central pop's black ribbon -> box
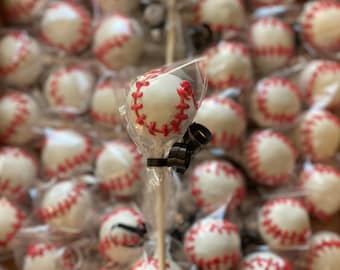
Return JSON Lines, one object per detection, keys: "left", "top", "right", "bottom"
{"left": 95, "top": 141, "right": 143, "bottom": 197}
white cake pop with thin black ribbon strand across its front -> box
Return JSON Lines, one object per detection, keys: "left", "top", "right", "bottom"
{"left": 98, "top": 206, "right": 144, "bottom": 265}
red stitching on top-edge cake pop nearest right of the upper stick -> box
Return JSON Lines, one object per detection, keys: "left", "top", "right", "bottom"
{"left": 193, "top": 0, "right": 244, "bottom": 32}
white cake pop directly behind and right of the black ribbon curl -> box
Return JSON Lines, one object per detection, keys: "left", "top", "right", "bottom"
{"left": 194, "top": 96, "right": 247, "bottom": 148}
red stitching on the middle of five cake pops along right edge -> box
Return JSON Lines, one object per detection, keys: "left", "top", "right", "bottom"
{"left": 300, "top": 110, "right": 340, "bottom": 160}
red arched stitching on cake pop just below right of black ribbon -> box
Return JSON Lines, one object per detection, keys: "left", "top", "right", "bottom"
{"left": 190, "top": 160, "right": 246, "bottom": 210}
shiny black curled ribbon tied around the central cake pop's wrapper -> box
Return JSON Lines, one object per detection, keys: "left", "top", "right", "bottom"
{"left": 147, "top": 123, "right": 211, "bottom": 173}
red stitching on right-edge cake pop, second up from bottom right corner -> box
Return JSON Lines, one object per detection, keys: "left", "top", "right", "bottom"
{"left": 299, "top": 164, "right": 340, "bottom": 220}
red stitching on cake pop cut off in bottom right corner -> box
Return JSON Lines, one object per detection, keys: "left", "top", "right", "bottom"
{"left": 306, "top": 237, "right": 340, "bottom": 270}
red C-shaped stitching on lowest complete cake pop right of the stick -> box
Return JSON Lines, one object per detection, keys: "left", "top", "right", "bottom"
{"left": 184, "top": 220, "right": 241, "bottom": 269}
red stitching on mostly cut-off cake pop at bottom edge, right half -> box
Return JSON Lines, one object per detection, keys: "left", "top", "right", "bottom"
{"left": 242, "top": 254, "right": 293, "bottom": 270}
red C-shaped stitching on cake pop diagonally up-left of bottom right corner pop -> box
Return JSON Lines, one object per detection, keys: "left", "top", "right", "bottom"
{"left": 261, "top": 198, "right": 310, "bottom": 245}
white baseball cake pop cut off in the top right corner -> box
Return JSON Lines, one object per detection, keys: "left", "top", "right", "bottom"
{"left": 300, "top": 0, "right": 340, "bottom": 51}
